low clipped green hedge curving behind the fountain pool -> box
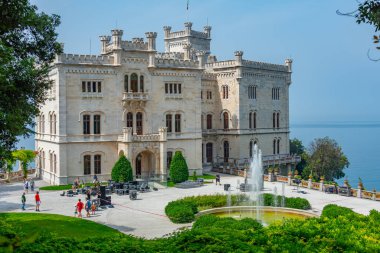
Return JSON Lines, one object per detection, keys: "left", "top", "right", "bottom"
{"left": 165, "top": 193, "right": 311, "bottom": 223}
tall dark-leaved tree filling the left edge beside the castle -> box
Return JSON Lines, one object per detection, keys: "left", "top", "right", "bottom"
{"left": 0, "top": 0, "right": 62, "bottom": 162}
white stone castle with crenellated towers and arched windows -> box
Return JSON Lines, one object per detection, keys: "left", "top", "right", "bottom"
{"left": 35, "top": 22, "right": 294, "bottom": 184}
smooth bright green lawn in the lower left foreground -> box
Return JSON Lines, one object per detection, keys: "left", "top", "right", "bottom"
{"left": 0, "top": 213, "right": 122, "bottom": 240}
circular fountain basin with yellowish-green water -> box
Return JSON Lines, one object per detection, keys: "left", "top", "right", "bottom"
{"left": 196, "top": 206, "right": 318, "bottom": 226}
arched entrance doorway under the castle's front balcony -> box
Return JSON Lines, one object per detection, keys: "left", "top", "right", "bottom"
{"left": 135, "top": 150, "right": 158, "bottom": 179}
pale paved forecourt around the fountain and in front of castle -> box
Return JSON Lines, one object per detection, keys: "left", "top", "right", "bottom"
{"left": 0, "top": 175, "right": 380, "bottom": 238}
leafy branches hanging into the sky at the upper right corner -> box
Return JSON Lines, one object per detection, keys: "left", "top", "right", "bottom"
{"left": 336, "top": 0, "right": 380, "bottom": 58}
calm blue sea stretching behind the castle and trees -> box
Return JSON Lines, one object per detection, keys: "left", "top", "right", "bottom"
{"left": 17, "top": 122, "right": 380, "bottom": 190}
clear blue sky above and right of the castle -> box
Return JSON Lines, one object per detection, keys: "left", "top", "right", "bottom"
{"left": 31, "top": 0, "right": 380, "bottom": 123}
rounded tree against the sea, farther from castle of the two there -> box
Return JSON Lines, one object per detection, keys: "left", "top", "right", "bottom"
{"left": 303, "top": 137, "right": 350, "bottom": 181}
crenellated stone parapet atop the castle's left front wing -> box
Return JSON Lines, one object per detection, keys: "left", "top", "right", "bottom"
{"left": 55, "top": 54, "right": 114, "bottom": 65}
